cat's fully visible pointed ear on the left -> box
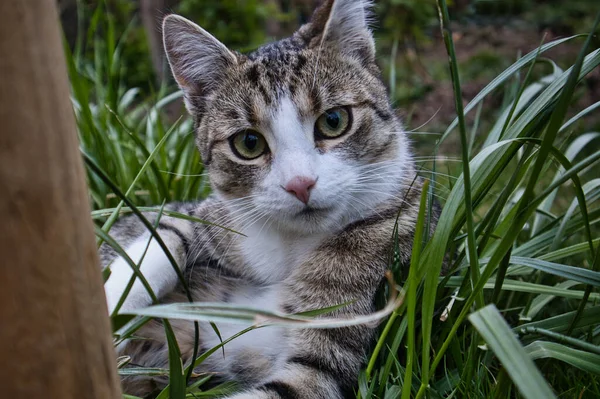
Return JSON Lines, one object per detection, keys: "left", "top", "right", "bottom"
{"left": 162, "top": 14, "right": 237, "bottom": 114}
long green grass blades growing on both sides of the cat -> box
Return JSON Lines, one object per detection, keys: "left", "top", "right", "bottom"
{"left": 67, "top": 1, "right": 600, "bottom": 399}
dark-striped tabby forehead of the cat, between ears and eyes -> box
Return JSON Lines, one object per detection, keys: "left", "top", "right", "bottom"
{"left": 210, "top": 43, "right": 376, "bottom": 125}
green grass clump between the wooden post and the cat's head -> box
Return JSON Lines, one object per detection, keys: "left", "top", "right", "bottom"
{"left": 66, "top": 2, "right": 207, "bottom": 209}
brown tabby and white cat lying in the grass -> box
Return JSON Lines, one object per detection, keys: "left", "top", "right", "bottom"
{"left": 100, "top": 0, "right": 428, "bottom": 399}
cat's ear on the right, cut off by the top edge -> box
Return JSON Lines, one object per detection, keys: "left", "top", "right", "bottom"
{"left": 311, "top": 0, "right": 375, "bottom": 65}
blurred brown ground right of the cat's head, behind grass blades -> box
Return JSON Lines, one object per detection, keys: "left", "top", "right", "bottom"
{"left": 397, "top": 20, "right": 600, "bottom": 154}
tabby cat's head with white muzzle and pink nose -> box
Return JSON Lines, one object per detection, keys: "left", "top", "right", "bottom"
{"left": 163, "top": 0, "right": 412, "bottom": 233}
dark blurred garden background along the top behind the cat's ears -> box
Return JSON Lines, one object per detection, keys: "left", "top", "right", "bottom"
{"left": 58, "top": 0, "right": 600, "bottom": 136}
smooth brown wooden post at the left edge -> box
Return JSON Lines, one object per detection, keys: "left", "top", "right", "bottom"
{"left": 0, "top": 0, "right": 120, "bottom": 399}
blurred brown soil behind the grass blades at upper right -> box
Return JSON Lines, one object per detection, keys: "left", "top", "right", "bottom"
{"left": 404, "top": 22, "right": 600, "bottom": 154}
